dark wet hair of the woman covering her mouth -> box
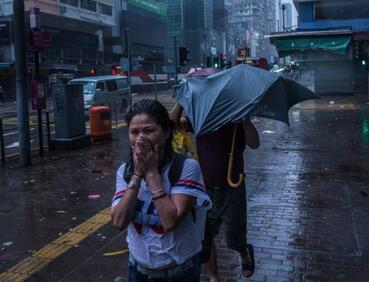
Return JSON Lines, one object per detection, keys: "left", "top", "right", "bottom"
{"left": 125, "top": 99, "right": 174, "bottom": 155}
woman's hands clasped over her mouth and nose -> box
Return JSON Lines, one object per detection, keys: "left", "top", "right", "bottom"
{"left": 132, "top": 136, "right": 159, "bottom": 176}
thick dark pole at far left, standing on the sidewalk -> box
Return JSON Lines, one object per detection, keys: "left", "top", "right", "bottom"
{"left": 13, "top": 0, "right": 31, "bottom": 167}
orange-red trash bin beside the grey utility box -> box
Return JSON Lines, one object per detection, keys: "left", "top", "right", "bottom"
{"left": 90, "top": 106, "right": 112, "bottom": 141}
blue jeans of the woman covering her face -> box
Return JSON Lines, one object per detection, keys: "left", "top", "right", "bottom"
{"left": 128, "top": 254, "right": 201, "bottom": 282}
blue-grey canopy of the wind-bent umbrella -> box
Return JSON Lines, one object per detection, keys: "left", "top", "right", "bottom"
{"left": 177, "top": 64, "right": 318, "bottom": 135}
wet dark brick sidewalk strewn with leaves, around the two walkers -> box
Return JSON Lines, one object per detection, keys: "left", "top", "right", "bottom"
{"left": 0, "top": 93, "right": 369, "bottom": 281}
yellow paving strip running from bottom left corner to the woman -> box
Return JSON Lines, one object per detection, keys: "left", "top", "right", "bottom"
{"left": 0, "top": 208, "right": 110, "bottom": 282}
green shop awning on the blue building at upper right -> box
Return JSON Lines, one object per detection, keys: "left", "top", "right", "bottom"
{"left": 271, "top": 36, "right": 351, "bottom": 57}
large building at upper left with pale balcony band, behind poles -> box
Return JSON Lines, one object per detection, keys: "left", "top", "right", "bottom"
{"left": 0, "top": 0, "right": 115, "bottom": 99}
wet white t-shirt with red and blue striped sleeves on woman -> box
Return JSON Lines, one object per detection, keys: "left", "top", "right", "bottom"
{"left": 112, "top": 159, "right": 211, "bottom": 268}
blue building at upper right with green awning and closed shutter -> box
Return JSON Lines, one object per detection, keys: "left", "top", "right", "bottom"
{"left": 270, "top": 0, "right": 369, "bottom": 94}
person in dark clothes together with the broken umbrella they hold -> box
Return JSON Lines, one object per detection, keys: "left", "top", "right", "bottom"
{"left": 173, "top": 64, "right": 319, "bottom": 281}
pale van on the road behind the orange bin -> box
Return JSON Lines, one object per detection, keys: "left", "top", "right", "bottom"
{"left": 68, "top": 75, "right": 129, "bottom": 115}
